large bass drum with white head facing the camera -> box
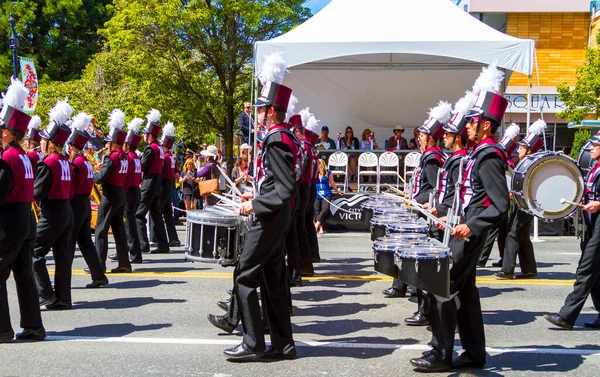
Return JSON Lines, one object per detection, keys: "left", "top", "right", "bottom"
{"left": 511, "top": 152, "right": 584, "bottom": 221}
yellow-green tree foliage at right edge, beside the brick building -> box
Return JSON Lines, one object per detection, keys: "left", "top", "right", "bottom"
{"left": 557, "top": 34, "right": 600, "bottom": 123}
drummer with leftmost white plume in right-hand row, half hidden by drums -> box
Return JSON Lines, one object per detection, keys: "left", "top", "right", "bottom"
{"left": 398, "top": 101, "right": 452, "bottom": 326}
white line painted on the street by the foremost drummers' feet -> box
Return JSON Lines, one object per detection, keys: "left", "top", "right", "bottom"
{"left": 46, "top": 336, "right": 600, "bottom": 356}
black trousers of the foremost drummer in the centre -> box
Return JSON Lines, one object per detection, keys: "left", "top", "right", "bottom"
{"left": 235, "top": 203, "right": 294, "bottom": 352}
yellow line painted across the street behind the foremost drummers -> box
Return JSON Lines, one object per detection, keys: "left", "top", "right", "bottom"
{"left": 57, "top": 269, "right": 575, "bottom": 286}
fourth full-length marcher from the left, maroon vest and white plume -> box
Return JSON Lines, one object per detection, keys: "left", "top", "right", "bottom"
{"left": 94, "top": 109, "right": 131, "bottom": 273}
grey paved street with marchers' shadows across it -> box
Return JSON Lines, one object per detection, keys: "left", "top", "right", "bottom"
{"left": 0, "top": 227, "right": 600, "bottom": 376}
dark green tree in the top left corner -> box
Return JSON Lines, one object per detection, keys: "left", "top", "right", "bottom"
{"left": 0, "top": 0, "right": 112, "bottom": 87}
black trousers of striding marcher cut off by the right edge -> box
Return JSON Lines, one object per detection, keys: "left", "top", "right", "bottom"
{"left": 559, "top": 219, "right": 600, "bottom": 325}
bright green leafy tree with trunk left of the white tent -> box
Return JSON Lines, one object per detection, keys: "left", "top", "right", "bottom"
{"left": 101, "top": 0, "right": 310, "bottom": 161}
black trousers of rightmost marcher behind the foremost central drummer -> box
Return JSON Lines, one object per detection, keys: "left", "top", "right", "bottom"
{"left": 296, "top": 183, "right": 318, "bottom": 275}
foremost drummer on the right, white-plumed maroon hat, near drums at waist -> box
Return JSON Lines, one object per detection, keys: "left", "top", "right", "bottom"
{"left": 410, "top": 66, "right": 509, "bottom": 372}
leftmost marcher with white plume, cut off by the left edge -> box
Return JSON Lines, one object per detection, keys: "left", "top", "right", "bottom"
{"left": 0, "top": 80, "right": 46, "bottom": 343}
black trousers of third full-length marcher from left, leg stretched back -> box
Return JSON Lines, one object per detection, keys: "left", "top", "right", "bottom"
{"left": 70, "top": 194, "right": 106, "bottom": 280}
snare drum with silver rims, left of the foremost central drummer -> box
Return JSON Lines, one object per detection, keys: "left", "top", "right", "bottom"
{"left": 185, "top": 210, "right": 243, "bottom": 263}
